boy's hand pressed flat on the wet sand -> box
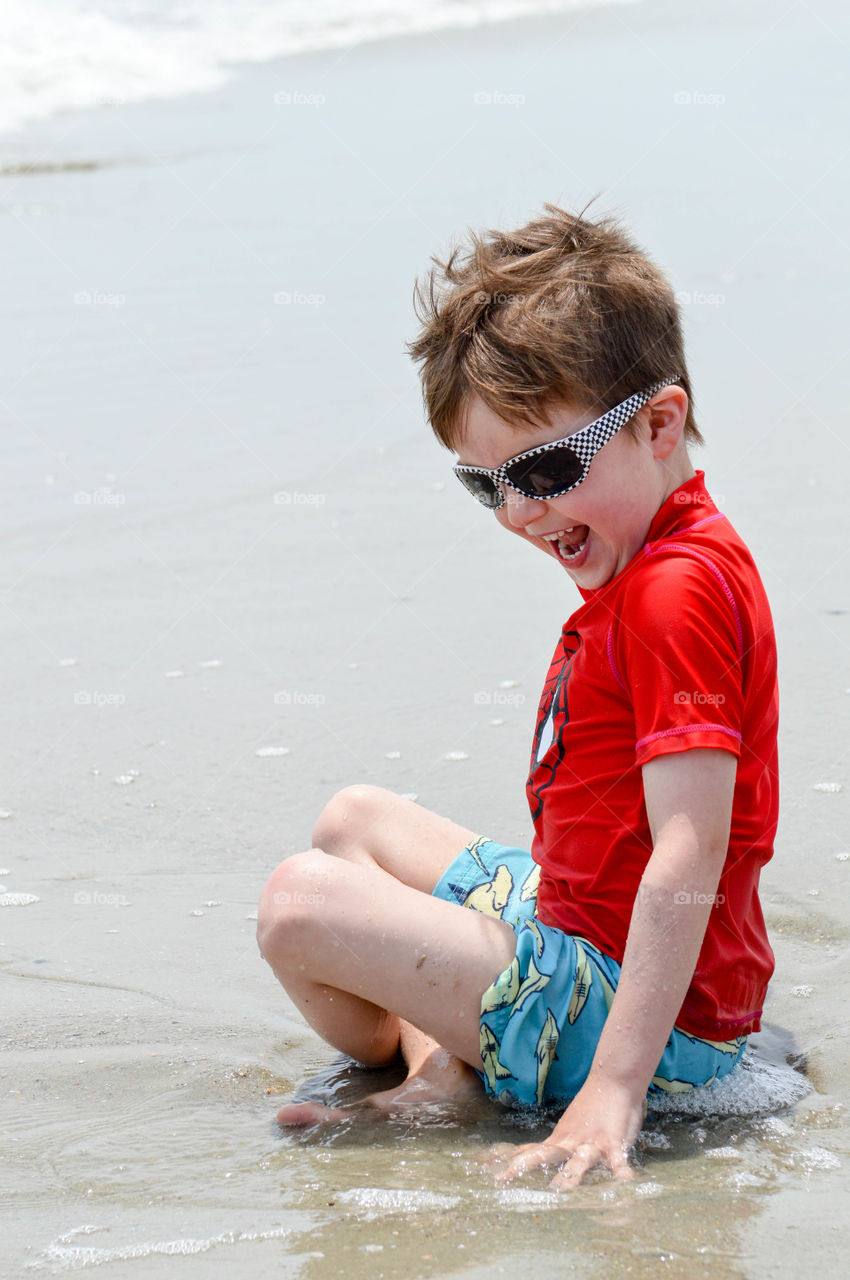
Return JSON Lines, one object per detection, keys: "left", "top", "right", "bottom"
{"left": 483, "top": 1076, "right": 646, "bottom": 1190}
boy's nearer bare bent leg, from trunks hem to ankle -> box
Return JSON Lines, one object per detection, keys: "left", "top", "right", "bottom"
{"left": 257, "top": 850, "right": 516, "bottom": 1095}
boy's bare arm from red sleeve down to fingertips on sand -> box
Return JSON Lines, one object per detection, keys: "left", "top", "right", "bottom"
{"left": 491, "top": 748, "right": 737, "bottom": 1188}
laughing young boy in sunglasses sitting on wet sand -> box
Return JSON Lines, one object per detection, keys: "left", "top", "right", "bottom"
{"left": 259, "top": 205, "right": 777, "bottom": 1187}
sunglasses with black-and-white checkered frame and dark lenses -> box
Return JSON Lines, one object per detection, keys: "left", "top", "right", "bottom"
{"left": 452, "top": 376, "right": 678, "bottom": 511}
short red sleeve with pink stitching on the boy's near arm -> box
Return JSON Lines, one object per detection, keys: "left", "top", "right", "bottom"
{"left": 616, "top": 552, "right": 744, "bottom": 764}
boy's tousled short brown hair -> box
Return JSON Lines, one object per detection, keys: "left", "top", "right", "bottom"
{"left": 407, "top": 204, "right": 703, "bottom": 449}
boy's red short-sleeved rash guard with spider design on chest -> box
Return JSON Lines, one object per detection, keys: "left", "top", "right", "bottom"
{"left": 527, "top": 471, "right": 778, "bottom": 1041}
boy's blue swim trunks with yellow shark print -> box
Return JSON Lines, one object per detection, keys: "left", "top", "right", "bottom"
{"left": 434, "top": 836, "right": 746, "bottom": 1106}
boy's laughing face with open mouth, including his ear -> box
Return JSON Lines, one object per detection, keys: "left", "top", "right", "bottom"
{"left": 458, "top": 387, "right": 694, "bottom": 591}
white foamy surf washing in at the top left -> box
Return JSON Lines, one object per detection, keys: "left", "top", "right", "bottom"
{"left": 0, "top": 0, "right": 635, "bottom": 131}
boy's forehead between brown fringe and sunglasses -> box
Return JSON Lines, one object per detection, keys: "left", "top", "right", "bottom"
{"left": 454, "top": 396, "right": 593, "bottom": 470}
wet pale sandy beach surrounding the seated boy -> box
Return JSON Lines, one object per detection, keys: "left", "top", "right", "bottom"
{"left": 0, "top": 0, "right": 850, "bottom": 1280}
